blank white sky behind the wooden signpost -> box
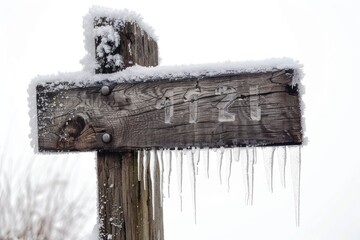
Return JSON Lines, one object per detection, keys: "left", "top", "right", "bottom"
{"left": 0, "top": 0, "right": 360, "bottom": 240}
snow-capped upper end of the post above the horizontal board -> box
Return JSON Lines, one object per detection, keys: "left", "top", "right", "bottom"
{"left": 82, "top": 6, "right": 158, "bottom": 73}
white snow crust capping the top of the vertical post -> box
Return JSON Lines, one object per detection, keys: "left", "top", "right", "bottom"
{"left": 81, "top": 6, "right": 157, "bottom": 72}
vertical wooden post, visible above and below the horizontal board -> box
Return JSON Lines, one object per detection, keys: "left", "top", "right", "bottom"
{"left": 94, "top": 17, "right": 164, "bottom": 240}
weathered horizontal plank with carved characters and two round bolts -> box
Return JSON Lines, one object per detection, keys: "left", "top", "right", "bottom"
{"left": 37, "top": 69, "right": 302, "bottom": 151}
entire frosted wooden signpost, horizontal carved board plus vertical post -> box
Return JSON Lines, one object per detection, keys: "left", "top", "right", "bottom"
{"left": 36, "top": 8, "right": 302, "bottom": 240}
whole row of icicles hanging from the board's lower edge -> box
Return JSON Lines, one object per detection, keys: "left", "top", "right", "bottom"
{"left": 137, "top": 146, "right": 301, "bottom": 226}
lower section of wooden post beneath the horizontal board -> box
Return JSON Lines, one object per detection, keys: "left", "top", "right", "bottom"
{"left": 97, "top": 151, "right": 164, "bottom": 240}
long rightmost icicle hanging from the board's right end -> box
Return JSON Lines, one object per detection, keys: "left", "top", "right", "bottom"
{"left": 289, "top": 146, "right": 301, "bottom": 226}
